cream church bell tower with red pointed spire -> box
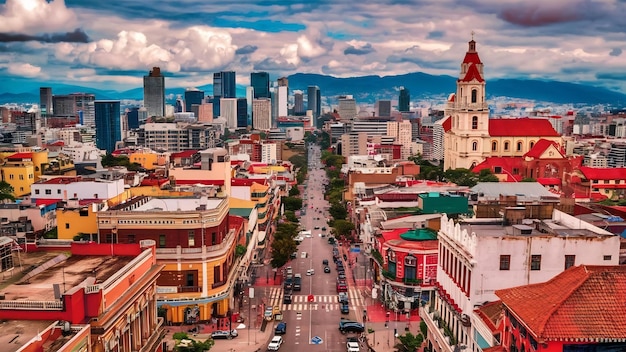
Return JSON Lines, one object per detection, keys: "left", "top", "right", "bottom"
{"left": 444, "top": 37, "right": 490, "bottom": 170}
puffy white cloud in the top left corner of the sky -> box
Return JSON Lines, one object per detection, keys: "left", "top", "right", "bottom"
{"left": 0, "top": 0, "right": 77, "bottom": 34}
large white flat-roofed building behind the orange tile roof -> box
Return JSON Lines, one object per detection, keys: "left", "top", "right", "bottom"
{"left": 420, "top": 210, "right": 620, "bottom": 352}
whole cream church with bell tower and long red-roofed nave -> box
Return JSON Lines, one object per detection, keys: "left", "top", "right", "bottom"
{"left": 443, "top": 38, "right": 563, "bottom": 170}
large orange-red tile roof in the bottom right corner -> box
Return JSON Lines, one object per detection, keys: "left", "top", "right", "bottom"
{"left": 495, "top": 265, "right": 626, "bottom": 342}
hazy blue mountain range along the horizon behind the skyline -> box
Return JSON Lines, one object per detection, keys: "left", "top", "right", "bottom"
{"left": 0, "top": 72, "right": 626, "bottom": 107}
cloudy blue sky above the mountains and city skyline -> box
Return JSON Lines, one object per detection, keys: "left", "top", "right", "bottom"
{"left": 0, "top": 0, "right": 626, "bottom": 93}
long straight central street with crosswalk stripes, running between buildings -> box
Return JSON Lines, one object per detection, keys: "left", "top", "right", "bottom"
{"left": 267, "top": 146, "right": 364, "bottom": 351}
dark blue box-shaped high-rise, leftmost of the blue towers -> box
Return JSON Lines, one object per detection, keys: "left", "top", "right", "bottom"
{"left": 94, "top": 100, "right": 122, "bottom": 153}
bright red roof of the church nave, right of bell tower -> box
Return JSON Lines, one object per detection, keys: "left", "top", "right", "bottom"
{"left": 489, "top": 117, "right": 560, "bottom": 137}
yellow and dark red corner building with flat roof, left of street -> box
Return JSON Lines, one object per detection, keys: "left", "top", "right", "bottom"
{"left": 98, "top": 195, "right": 241, "bottom": 324}
